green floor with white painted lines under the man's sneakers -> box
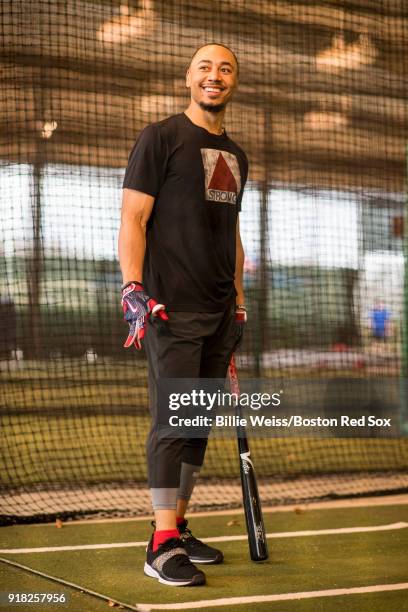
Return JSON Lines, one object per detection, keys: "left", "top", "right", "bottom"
{"left": 0, "top": 504, "right": 408, "bottom": 612}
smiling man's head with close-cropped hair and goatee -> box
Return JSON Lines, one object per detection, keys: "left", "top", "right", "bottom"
{"left": 186, "top": 43, "right": 238, "bottom": 113}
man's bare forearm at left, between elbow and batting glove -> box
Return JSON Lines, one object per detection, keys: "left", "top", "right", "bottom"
{"left": 119, "top": 218, "right": 146, "bottom": 283}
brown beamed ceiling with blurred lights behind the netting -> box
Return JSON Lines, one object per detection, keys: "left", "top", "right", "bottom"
{"left": 0, "top": 0, "right": 408, "bottom": 193}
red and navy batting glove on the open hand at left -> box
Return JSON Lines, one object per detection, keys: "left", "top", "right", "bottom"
{"left": 122, "top": 281, "right": 168, "bottom": 350}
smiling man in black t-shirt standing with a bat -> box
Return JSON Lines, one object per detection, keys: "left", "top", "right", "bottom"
{"left": 119, "top": 44, "right": 248, "bottom": 586}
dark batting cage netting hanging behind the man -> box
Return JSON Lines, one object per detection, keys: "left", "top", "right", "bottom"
{"left": 0, "top": 0, "right": 408, "bottom": 521}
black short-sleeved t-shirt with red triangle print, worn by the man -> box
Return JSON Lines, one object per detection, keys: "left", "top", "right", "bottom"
{"left": 123, "top": 113, "right": 248, "bottom": 312}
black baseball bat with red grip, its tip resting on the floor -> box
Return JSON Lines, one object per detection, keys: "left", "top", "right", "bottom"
{"left": 228, "top": 355, "right": 268, "bottom": 561}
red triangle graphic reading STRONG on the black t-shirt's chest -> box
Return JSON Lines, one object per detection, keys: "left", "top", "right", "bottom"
{"left": 201, "top": 149, "right": 241, "bottom": 204}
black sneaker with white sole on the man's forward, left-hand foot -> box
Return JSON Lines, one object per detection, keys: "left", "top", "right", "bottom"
{"left": 144, "top": 538, "right": 205, "bottom": 586}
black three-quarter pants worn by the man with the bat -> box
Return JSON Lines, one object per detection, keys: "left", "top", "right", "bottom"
{"left": 145, "top": 304, "right": 236, "bottom": 490}
